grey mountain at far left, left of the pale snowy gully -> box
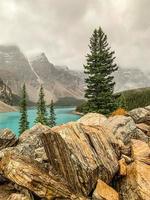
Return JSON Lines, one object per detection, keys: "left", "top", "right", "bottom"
{"left": 0, "top": 45, "right": 38, "bottom": 100}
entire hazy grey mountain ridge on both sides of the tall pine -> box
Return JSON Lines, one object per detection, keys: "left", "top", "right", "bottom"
{"left": 0, "top": 45, "right": 150, "bottom": 103}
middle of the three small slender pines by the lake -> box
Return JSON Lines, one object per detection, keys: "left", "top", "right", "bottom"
{"left": 35, "top": 85, "right": 48, "bottom": 125}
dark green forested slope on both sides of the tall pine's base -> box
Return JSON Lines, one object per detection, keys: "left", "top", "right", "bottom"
{"left": 76, "top": 88, "right": 150, "bottom": 113}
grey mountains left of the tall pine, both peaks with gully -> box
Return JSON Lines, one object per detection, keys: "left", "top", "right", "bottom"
{"left": 0, "top": 45, "right": 83, "bottom": 102}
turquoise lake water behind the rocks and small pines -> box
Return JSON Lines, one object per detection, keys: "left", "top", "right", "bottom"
{"left": 0, "top": 107, "right": 80, "bottom": 134}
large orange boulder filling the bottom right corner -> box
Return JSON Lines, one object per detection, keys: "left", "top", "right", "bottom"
{"left": 120, "top": 161, "right": 150, "bottom": 200}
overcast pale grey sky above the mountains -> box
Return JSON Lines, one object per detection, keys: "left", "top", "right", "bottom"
{"left": 0, "top": 0, "right": 150, "bottom": 69}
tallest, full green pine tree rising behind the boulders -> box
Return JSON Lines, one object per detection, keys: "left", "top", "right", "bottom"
{"left": 84, "top": 28, "right": 118, "bottom": 114}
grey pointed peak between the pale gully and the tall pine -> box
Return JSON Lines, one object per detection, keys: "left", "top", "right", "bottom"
{"left": 30, "top": 53, "right": 84, "bottom": 100}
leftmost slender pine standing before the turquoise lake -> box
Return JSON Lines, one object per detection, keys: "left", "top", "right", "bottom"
{"left": 19, "top": 84, "right": 29, "bottom": 135}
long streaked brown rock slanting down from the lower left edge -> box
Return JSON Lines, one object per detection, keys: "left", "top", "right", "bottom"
{"left": 0, "top": 152, "right": 83, "bottom": 200}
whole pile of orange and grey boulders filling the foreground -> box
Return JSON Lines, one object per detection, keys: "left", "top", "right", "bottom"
{"left": 0, "top": 106, "right": 150, "bottom": 200}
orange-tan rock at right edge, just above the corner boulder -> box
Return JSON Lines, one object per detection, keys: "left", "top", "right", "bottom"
{"left": 131, "top": 140, "right": 150, "bottom": 165}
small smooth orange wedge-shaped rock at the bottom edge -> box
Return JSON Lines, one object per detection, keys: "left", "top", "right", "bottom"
{"left": 92, "top": 180, "right": 119, "bottom": 200}
